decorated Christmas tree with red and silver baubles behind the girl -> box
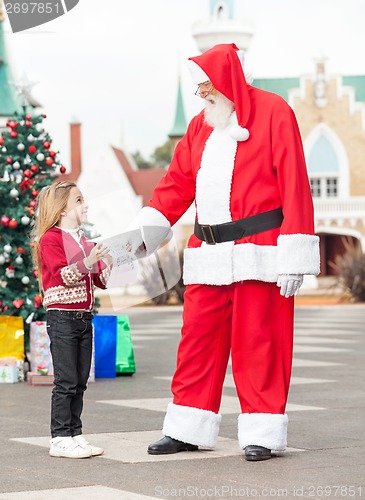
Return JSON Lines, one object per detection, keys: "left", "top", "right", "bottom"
{"left": 0, "top": 106, "right": 66, "bottom": 343}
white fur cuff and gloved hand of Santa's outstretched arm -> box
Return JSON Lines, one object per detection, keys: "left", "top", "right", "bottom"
{"left": 137, "top": 207, "right": 172, "bottom": 255}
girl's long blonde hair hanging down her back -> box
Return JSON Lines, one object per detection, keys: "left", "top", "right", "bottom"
{"left": 31, "top": 181, "right": 77, "bottom": 291}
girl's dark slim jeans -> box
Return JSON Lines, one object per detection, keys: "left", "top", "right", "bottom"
{"left": 47, "top": 310, "right": 93, "bottom": 437}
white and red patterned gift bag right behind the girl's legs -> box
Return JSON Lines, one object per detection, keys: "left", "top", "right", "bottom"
{"left": 30, "top": 321, "right": 53, "bottom": 375}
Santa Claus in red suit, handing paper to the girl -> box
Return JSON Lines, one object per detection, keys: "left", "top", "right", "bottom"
{"left": 132, "top": 44, "right": 319, "bottom": 461}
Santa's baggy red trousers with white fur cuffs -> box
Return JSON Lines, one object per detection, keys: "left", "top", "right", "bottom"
{"left": 163, "top": 281, "right": 294, "bottom": 450}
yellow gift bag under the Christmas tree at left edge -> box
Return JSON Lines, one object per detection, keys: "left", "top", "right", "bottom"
{"left": 0, "top": 316, "right": 24, "bottom": 361}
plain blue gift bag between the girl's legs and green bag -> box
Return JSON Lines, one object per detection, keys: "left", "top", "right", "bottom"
{"left": 93, "top": 315, "right": 117, "bottom": 378}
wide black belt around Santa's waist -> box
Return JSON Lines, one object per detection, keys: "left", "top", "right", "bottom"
{"left": 194, "top": 207, "right": 284, "bottom": 245}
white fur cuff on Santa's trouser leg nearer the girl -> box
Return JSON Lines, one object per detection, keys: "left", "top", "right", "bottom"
{"left": 162, "top": 403, "right": 222, "bottom": 449}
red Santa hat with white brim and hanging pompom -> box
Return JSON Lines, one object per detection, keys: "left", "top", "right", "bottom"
{"left": 188, "top": 43, "right": 251, "bottom": 141}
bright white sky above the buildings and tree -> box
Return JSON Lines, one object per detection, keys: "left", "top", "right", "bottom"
{"left": 2, "top": 0, "right": 365, "bottom": 170}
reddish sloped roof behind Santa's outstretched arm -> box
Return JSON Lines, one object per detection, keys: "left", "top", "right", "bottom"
{"left": 112, "top": 146, "right": 166, "bottom": 206}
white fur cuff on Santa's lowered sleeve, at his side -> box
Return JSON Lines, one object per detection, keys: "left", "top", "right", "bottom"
{"left": 277, "top": 234, "right": 320, "bottom": 275}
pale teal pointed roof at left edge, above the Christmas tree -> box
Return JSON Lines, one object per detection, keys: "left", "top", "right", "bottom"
{"left": 0, "top": 18, "right": 20, "bottom": 116}
